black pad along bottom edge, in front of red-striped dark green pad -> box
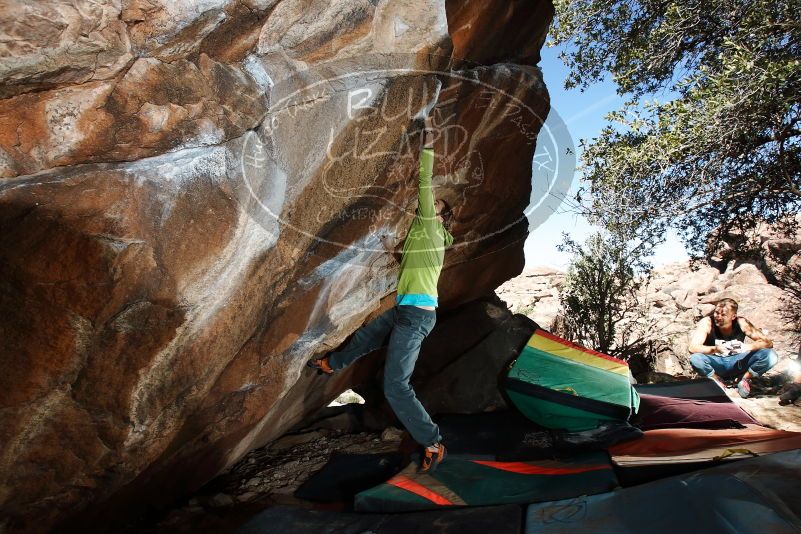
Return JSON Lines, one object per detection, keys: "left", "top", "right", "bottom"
{"left": 237, "top": 504, "right": 523, "bottom": 534}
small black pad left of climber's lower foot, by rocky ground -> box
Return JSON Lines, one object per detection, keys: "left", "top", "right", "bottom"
{"left": 294, "top": 452, "right": 408, "bottom": 502}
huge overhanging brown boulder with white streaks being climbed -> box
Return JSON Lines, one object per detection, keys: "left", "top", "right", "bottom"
{"left": 0, "top": 0, "right": 552, "bottom": 530}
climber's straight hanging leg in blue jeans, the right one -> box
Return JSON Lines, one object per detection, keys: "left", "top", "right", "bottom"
{"left": 384, "top": 306, "right": 442, "bottom": 447}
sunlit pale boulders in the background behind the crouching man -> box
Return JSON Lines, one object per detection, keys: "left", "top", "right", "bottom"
{"left": 497, "top": 262, "right": 798, "bottom": 376}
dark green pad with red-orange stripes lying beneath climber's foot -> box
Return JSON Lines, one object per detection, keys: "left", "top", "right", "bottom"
{"left": 355, "top": 453, "right": 617, "bottom": 512}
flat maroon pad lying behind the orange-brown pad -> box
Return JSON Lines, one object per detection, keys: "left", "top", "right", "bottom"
{"left": 632, "top": 392, "right": 759, "bottom": 430}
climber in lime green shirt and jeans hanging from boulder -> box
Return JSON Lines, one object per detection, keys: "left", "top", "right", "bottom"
{"left": 307, "top": 107, "right": 453, "bottom": 472}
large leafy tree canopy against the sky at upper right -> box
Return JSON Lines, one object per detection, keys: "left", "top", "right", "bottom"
{"left": 552, "top": 0, "right": 801, "bottom": 256}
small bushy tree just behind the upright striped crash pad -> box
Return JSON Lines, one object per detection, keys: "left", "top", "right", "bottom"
{"left": 559, "top": 233, "right": 651, "bottom": 358}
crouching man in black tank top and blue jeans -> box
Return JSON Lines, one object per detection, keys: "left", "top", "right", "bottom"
{"left": 688, "top": 299, "right": 779, "bottom": 398}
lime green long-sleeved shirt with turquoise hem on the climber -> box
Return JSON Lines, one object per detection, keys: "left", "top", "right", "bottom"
{"left": 396, "top": 148, "right": 453, "bottom": 306}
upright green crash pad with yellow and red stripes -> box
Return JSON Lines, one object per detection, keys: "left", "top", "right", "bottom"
{"left": 505, "top": 330, "right": 639, "bottom": 432}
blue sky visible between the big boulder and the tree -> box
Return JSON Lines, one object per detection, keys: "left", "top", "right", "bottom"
{"left": 524, "top": 42, "right": 688, "bottom": 270}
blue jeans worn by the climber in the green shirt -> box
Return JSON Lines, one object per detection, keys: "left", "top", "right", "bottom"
{"left": 328, "top": 306, "right": 442, "bottom": 447}
